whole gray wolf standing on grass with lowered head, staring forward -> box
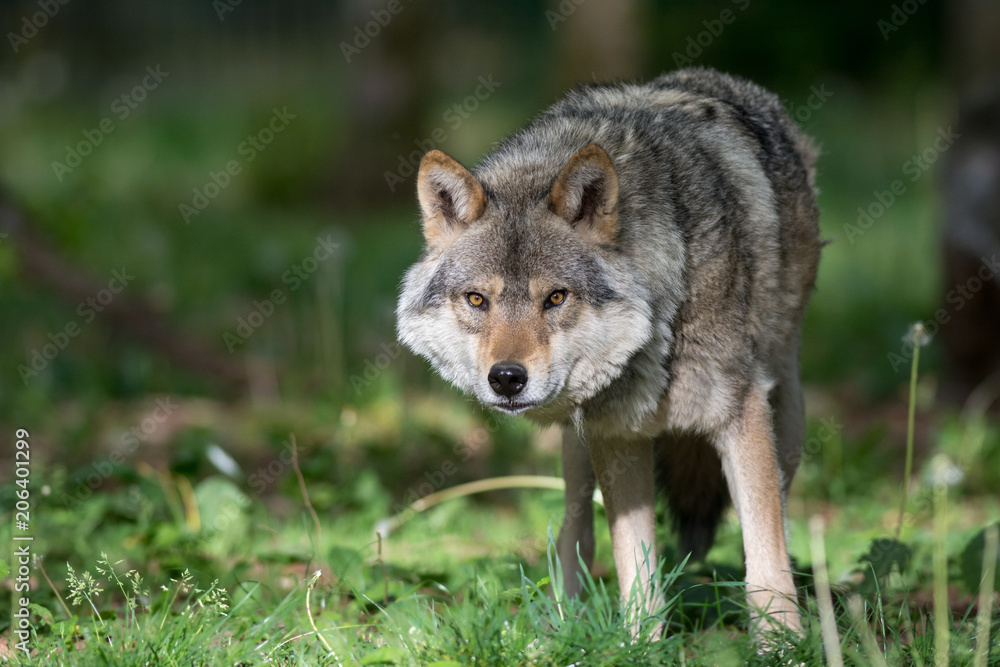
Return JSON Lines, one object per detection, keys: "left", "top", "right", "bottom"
{"left": 397, "top": 69, "right": 822, "bottom": 630}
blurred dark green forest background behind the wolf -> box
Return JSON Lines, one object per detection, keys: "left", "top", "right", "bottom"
{"left": 0, "top": 0, "right": 1000, "bottom": 656}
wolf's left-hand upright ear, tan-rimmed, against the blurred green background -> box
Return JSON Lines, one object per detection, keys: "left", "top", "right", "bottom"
{"left": 417, "top": 150, "right": 486, "bottom": 248}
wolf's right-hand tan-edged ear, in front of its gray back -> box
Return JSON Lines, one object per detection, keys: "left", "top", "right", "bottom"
{"left": 549, "top": 144, "right": 618, "bottom": 243}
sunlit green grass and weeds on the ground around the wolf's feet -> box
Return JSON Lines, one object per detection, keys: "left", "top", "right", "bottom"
{"left": 0, "top": 392, "right": 1000, "bottom": 665}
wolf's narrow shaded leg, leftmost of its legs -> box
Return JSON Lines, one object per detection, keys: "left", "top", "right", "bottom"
{"left": 556, "top": 427, "right": 595, "bottom": 597}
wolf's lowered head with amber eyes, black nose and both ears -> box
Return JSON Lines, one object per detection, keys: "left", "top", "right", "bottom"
{"left": 397, "top": 144, "right": 652, "bottom": 419}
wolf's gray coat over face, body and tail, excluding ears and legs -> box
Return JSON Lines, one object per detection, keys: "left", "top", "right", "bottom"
{"left": 397, "top": 69, "right": 822, "bottom": 576}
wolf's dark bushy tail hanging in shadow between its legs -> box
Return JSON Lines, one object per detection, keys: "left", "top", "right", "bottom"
{"left": 655, "top": 433, "right": 729, "bottom": 559}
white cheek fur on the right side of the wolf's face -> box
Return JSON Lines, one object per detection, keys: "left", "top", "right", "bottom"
{"left": 553, "top": 302, "right": 652, "bottom": 403}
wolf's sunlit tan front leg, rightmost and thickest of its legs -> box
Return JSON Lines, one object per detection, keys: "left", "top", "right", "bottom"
{"left": 719, "top": 391, "right": 802, "bottom": 632}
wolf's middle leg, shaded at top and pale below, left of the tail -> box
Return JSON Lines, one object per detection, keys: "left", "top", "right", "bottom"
{"left": 589, "top": 439, "right": 661, "bottom": 631}
